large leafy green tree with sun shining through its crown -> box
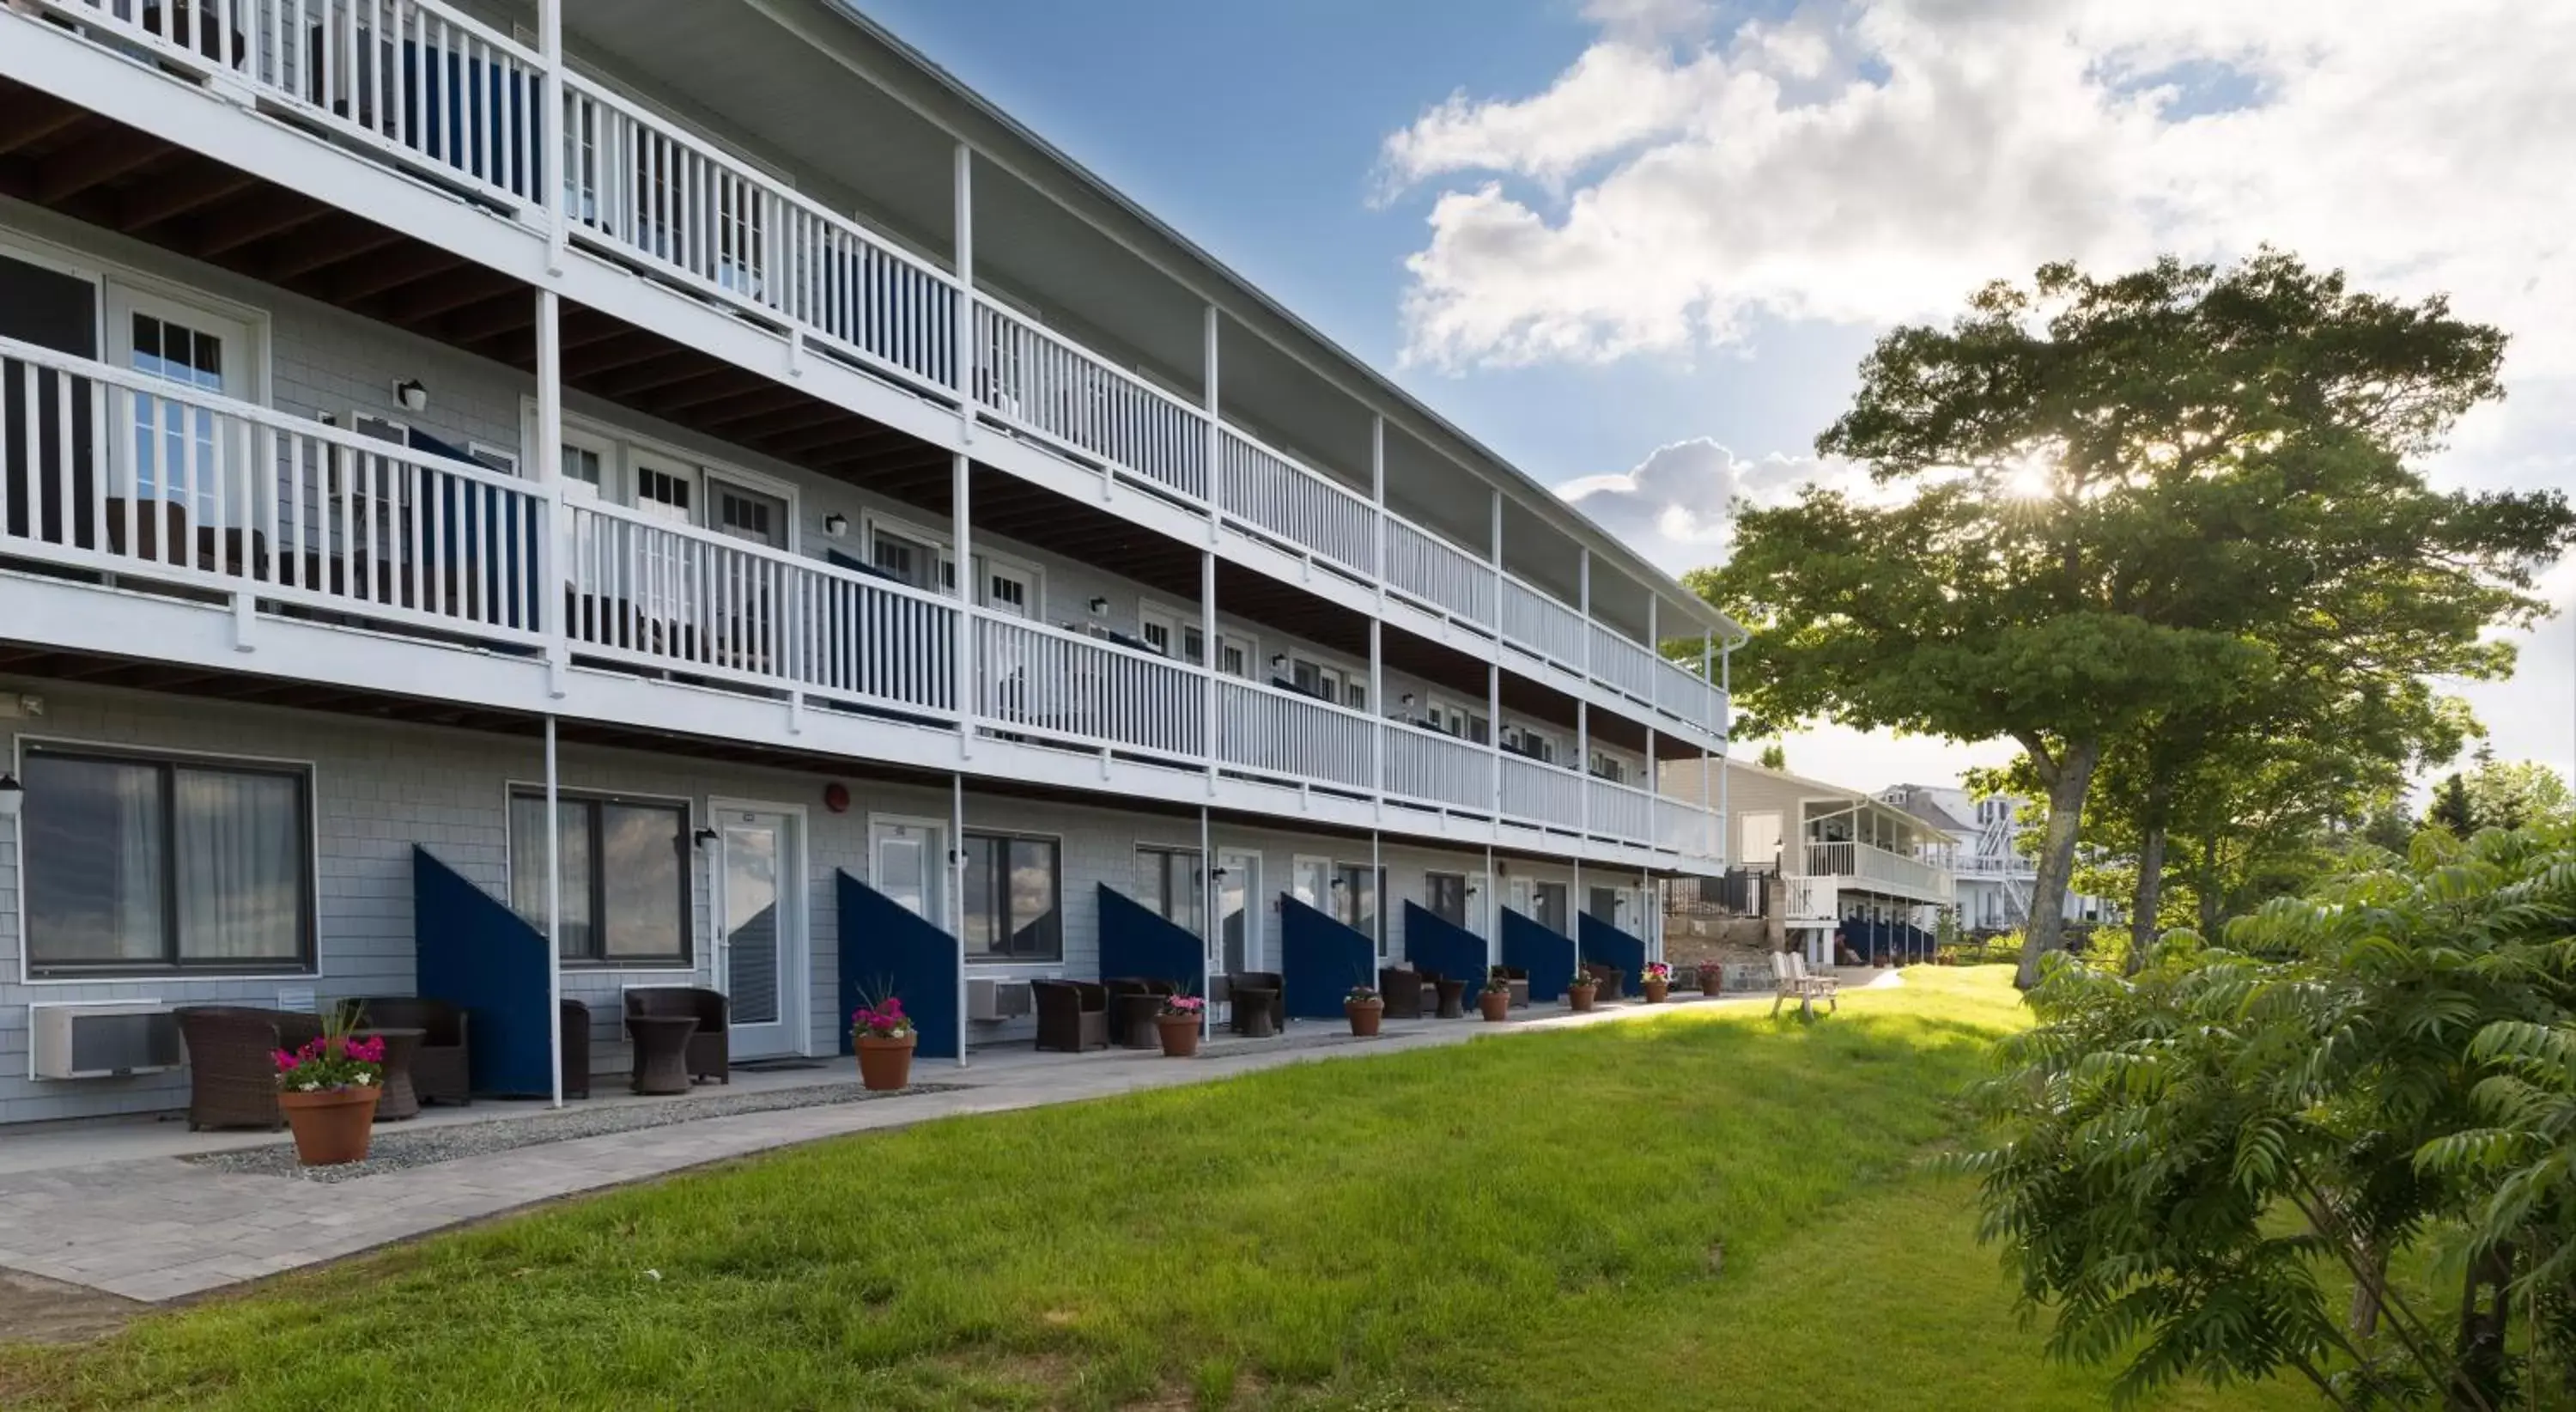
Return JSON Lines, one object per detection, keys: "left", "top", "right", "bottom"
{"left": 1695, "top": 250, "right": 2571, "bottom": 987}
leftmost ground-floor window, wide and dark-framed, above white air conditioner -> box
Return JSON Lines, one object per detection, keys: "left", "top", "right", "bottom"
{"left": 21, "top": 747, "right": 314, "bottom": 977}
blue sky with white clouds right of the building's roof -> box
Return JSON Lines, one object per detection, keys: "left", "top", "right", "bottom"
{"left": 855, "top": 0, "right": 2576, "bottom": 788}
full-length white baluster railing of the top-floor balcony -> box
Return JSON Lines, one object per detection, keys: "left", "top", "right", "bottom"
{"left": 15, "top": 0, "right": 1726, "bottom": 734}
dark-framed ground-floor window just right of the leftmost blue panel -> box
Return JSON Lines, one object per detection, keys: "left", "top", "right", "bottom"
{"left": 510, "top": 791, "right": 690, "bottom": 966}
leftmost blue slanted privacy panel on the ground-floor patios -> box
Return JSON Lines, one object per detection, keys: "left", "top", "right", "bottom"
{"left": 412, "top": 845, "right": 554, "bottom": 1098}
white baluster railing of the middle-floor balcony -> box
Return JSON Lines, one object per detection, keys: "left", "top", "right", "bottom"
{"left": 0, "top": 338, "right": 1718, "bottom": 858}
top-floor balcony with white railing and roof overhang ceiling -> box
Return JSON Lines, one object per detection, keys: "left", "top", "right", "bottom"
{"left": 0, "top": 0, "right": 1728, "bottom": 745}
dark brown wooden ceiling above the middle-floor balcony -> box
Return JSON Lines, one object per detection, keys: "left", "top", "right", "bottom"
{"left": 0, "top": 80, "right": 1646, "bottom": 750}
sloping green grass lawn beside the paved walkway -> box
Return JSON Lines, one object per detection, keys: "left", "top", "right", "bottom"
{"left": 0, "top": 969, "right": 2313, "bottom": 1412}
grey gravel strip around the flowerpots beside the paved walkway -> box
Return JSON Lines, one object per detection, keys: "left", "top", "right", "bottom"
{"left": 180, "top": 1082, "right": 966, "bottom": 1183}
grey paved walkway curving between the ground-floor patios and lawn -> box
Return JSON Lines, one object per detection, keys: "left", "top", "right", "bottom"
{"left": 0, "top": 995, "right": 1793, "bottom": 1301}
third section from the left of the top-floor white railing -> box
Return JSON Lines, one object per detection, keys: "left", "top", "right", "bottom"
{"left": 974, "top": 296, "right": 1208, "bottom": 502}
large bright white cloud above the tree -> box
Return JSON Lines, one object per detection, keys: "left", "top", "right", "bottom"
{"left": 1381, "top": 0, "right": 2576, "bottom": 376}
